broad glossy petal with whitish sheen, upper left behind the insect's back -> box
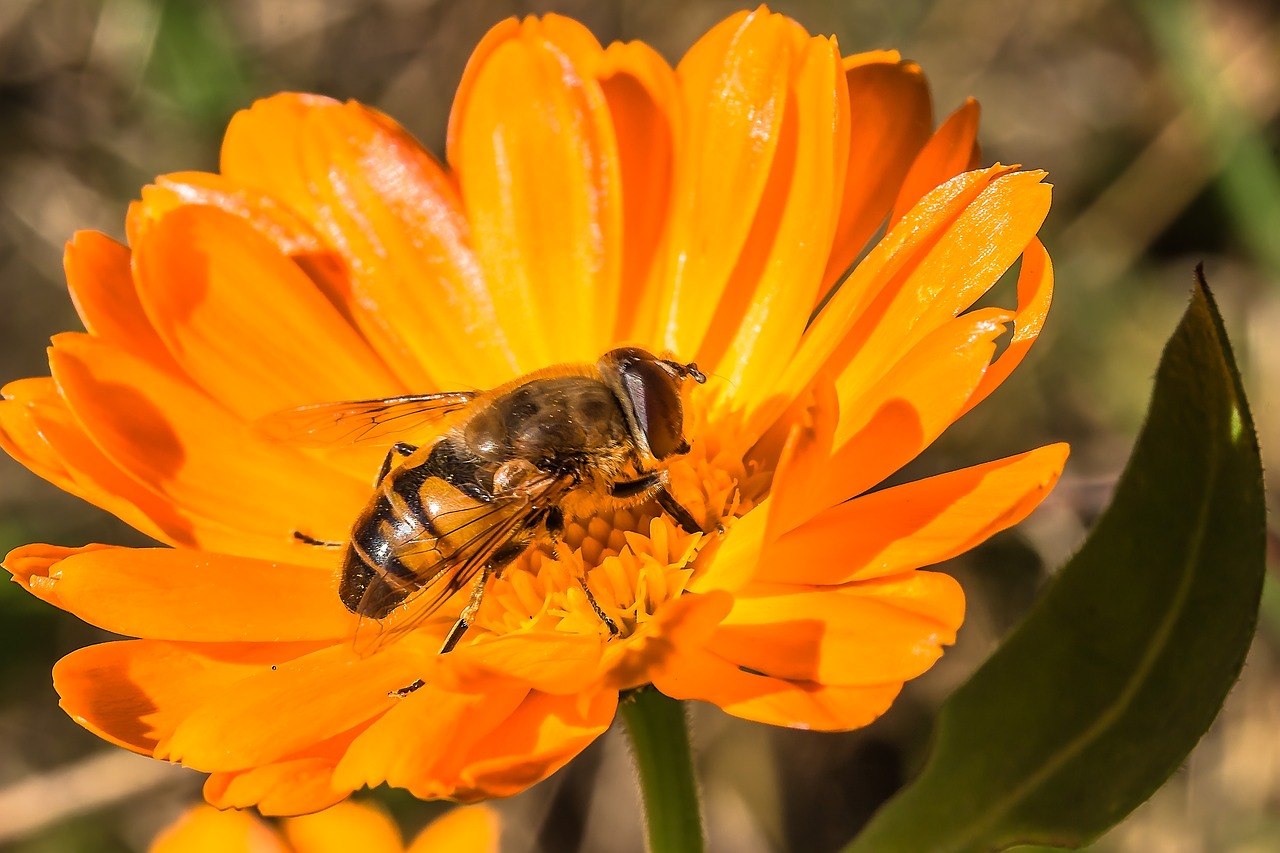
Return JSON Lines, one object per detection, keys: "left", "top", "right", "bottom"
{"left": 223, "top": 95, "right": 518, "bottom": 392}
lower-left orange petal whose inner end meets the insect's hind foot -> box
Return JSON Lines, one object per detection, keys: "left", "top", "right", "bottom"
{"left": 156, "top": 643, "right": 420, "bottom": 771}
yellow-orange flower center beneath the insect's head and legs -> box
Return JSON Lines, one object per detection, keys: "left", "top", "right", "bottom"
{"left": 472, "top": 391, "right": 758, "bottom": 639}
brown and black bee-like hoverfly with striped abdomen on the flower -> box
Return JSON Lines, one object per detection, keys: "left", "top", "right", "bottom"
{"left": 259, "top": 347, "right": 707, "bottom": 654}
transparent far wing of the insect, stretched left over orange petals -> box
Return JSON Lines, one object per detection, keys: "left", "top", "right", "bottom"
{"left": 253, "top": 391, "right": 480, "bottom": 447}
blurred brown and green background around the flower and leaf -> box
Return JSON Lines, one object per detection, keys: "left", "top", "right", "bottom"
{"left": 0, "top": 0, "right": 1280, "bottom": 853}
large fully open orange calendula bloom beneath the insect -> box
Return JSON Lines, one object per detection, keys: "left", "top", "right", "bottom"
{"left": 0, "top": 9, "right": 1066, "bottom": 815}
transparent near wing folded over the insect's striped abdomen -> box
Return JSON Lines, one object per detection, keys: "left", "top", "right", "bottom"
{"left": 352, "top": 474, "right": 572, "bottom": 657}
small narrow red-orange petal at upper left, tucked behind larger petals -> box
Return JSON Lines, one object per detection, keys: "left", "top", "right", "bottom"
{"left": 63, "top": 231, "right": 177, "bottom": 369}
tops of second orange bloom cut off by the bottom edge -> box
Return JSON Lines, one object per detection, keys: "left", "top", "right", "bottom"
{"left": 151, "top": 803, "right": 499, "bottom": 853}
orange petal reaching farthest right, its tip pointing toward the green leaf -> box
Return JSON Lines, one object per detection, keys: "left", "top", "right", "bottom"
{"left": 756, "top": 444, "right": 1068, "bottom": 584}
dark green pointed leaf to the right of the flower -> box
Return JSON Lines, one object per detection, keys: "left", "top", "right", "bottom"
{"left": 846, "top": 270, "right": 1266, "bottom": 853}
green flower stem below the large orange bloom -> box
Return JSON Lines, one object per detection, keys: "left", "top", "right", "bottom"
{"left": 620, "top": 688, "right": 703, "bottom": 853}
